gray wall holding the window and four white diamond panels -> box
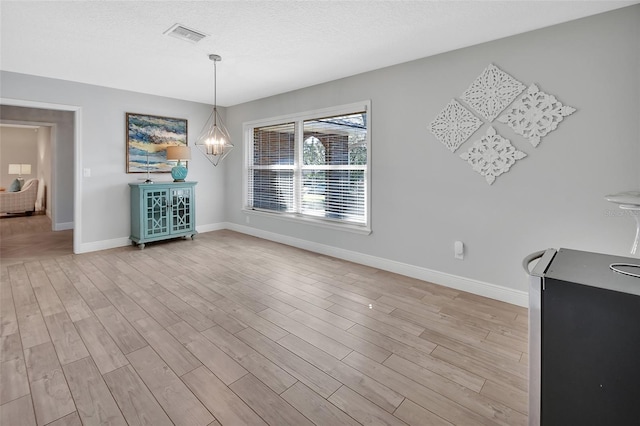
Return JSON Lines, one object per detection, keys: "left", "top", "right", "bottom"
{"left": 225, "top": 6, "right": 640, "bottom": 291}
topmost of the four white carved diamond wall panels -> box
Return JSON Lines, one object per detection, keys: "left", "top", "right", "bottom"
{"left": 460, "top": 64, "right": 526, "bottom": 122}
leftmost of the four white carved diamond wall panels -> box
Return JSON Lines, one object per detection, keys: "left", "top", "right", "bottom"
{"left": 429, "top": 99, "right": 482, "bottom": 152}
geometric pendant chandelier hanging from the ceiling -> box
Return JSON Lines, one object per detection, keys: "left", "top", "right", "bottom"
{"left": 196, "top": 54, "right": 233, "bottom": 166}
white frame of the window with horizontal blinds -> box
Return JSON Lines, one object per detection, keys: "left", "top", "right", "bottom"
{"left": 242, "top": 100, "right": 371, "bottom": 235}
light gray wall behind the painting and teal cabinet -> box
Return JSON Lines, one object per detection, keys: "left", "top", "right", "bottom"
{"left": 0, "top": 75, "right": 224, "bottom": 246}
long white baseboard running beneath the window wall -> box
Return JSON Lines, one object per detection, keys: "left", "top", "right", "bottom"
{"left": 225, "top": 223, "right": 529, "bottom": 307}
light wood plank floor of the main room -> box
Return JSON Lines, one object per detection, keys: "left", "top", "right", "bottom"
{"left": 0, "top": 225, "right": 528, "bottom": 426}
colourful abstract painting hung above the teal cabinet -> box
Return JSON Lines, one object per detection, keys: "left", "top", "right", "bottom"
{"left": 126, "top": 112, "right": 188, "bottom": 173}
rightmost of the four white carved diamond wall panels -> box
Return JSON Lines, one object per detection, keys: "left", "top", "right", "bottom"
{"left": 498, "top": 84, "right": 576, "bottom": 147}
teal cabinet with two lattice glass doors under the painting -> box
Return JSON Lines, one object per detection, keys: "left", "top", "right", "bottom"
{"left": 129, "top": 182, "right": 197, "bottom": 249}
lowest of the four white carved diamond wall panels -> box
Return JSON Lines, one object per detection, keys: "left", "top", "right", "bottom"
{"left": 460, "top": 127, "right": 527, "bottom": 185}
